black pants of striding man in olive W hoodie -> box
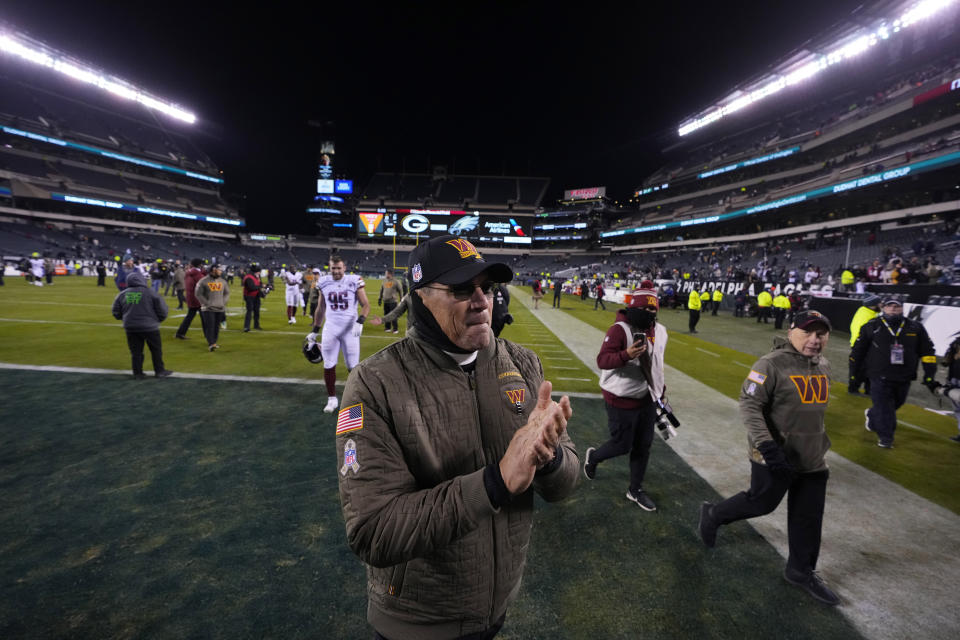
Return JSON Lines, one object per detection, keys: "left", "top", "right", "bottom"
{"left": 711, "top": 461, "right": 830, "bottom": 579}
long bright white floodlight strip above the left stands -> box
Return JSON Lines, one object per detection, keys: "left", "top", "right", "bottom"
{"left": 0, "top": 32, "right": 197, "bottom": 124}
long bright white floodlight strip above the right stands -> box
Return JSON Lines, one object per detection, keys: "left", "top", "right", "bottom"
{"left": 677, "top": 0, "right": 954, "bottom": 137}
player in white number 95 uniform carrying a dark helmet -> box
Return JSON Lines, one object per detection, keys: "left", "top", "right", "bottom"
{"left": 308, "top": 256, "right": 370, "bottom": 413}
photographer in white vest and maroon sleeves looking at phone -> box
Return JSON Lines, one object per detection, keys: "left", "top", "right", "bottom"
{"left": 583, "top": 280, "right": 672, "bottom": 511}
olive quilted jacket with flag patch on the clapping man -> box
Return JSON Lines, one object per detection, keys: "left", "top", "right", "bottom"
{"left": 337, "top": 329, "right": 580, "bottom": 640}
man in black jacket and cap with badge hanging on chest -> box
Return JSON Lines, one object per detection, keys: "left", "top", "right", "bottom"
{"left": 850, "top": 299, "right": 937, "bottom": 449}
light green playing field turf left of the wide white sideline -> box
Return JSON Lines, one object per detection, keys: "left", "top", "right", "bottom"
{"left": 0, "top": 276, "right": 597, "bottom": 393}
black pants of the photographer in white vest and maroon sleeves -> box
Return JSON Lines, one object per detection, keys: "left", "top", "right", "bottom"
{"left": 590, "top": 397, "right": 657, "bottom": 491}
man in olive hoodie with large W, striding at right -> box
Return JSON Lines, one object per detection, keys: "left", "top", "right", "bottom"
{"left": 699, "top": 311, "right": 840, "bottom": 605}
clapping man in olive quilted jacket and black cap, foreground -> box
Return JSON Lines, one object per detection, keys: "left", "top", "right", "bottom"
{"left": 336, "top": 235, "right": 579, "bottom": 640}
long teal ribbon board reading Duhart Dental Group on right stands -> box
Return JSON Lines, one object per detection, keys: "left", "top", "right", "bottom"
{"left": 600, "top": 151, "right": 960, "bottom": 238}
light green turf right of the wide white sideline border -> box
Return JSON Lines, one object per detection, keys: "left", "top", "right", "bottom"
{"left": 548, "top": 296, "right": 960, "bottom": 514}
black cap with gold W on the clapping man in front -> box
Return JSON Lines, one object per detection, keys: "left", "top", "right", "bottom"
{"left": 407, "top": 235, "right": 513, "bottom": 289}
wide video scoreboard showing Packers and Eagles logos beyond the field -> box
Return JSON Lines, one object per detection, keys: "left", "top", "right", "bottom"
{"left": 357, "top": 209, "right": 532, "bottom": 244}
